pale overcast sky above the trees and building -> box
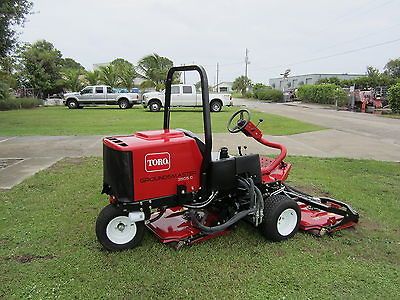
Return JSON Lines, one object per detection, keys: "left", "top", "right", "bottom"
{"left": 20, "top": 0, "right": 400, "bottom": 84}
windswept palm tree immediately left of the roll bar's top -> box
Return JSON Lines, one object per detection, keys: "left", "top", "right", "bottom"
{"left": 136, "top": 53, "right": 180, "bottom": 90}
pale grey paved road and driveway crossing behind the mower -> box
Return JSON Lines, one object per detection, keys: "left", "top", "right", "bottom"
{"left": 0, "top": 99, "right": 400, "bottom": 189}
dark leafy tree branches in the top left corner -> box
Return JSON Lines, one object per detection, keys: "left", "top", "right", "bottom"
{"left": 0, "top": 0, "right": 33, "bottom": 58}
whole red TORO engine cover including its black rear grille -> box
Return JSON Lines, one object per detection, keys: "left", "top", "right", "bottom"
{"left": 103, "top": 130, "right": 203, "bottom": 202}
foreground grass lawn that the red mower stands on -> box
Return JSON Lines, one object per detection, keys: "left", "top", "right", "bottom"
{"left": 0, "top": 157, "right": 400, "bottom": 299}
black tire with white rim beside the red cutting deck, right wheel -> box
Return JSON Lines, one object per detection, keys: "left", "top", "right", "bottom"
{"left": 259, "top": 195, "right": 301, "bottom": 242}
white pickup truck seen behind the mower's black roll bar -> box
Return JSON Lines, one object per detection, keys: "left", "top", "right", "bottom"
{"left": 142, "top": 84, "right": 233, "bottom": 112}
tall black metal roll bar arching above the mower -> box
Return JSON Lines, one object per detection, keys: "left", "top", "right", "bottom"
{"left": 164, "top": 65, "right": 212, "bottom": 188}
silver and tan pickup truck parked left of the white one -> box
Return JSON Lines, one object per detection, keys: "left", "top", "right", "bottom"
{"left": 63, "top": 85, "right": 141, "bottom": 109}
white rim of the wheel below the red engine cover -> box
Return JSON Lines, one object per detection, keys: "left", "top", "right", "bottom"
{"left": 106, "top": 216, "right": 137, "bottom": 245}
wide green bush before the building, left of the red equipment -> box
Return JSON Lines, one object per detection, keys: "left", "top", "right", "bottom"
{"left": 297, "top": 84, "right": 348, "bottom": 106}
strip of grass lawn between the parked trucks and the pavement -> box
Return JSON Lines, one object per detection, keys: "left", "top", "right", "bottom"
{"left": 0, "top": 107, "right": 323, "bottom": 136}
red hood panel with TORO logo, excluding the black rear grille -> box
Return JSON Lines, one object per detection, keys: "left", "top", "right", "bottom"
{"left": 103, "top": 130, "right": 203, "bottom": 201}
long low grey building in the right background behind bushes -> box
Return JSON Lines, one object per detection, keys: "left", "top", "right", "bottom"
{"left": 269, "top": 73, "right": 366, "bottom": 90}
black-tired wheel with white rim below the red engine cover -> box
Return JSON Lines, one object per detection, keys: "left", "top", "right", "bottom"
{"left": 96, "top": 204, "right": 145, "bottom": 251}
